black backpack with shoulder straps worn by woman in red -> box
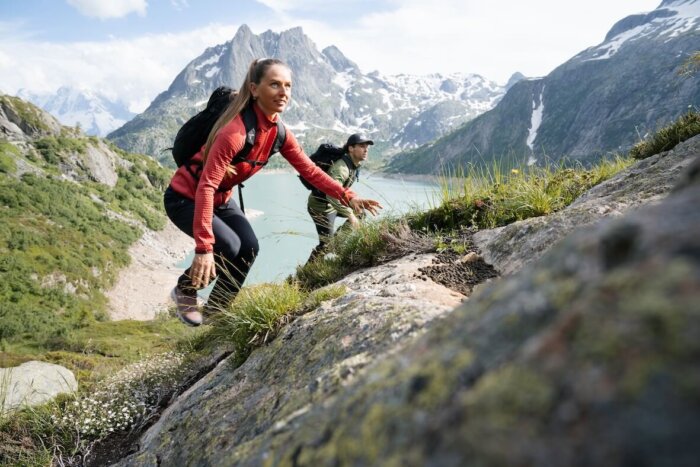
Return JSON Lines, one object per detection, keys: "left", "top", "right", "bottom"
{"left": 171, "top": 86, "right": 287, "bottom": 172}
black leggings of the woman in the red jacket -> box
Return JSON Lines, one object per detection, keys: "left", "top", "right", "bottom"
{"left": 163, "top": 187, "right": 260, "bottom": 312}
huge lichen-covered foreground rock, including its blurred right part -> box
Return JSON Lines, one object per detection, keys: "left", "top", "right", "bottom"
{"left": 120, "top": 149, "right": 700, "bottom": 466}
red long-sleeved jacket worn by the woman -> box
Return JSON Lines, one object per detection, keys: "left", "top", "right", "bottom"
{"left": 170, "top": 105, "right": 355, "bottom": 253}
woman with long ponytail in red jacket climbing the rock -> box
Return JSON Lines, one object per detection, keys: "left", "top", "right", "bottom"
{"left": 164, "top": 59, "right": 382, "bottom": 326}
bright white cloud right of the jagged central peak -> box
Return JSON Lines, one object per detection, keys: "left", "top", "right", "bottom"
{"left": 253, "top": 0, "right": 658, "bottom": 83}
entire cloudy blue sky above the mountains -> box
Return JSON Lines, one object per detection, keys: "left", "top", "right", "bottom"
{"left": 0, "top": 0, "right": 660, "bottom": 111}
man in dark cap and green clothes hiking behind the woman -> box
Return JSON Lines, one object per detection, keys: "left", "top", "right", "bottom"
{"left": 307, "top": 133, "right": 374, "bottom": 261}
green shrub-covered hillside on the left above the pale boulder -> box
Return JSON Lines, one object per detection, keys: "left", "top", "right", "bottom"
{"left": 0, "top": 96, "right": 194, "bottom": 381}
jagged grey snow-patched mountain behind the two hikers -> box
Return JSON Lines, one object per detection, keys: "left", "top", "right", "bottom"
{"left": 109, "top": 25, "right": 504, "bottom": 166}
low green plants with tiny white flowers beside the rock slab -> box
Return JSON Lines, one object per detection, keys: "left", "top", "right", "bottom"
{"left": 0, "top": 352, "right": 191, "bottom": 466}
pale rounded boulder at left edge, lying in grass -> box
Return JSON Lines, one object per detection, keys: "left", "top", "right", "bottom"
{"left": 0, "top": 361, "right": 78, "bottom": 411}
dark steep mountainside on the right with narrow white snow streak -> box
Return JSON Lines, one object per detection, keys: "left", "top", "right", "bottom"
{"left": 389, "top": 0, "right": 700, "bottom": 174}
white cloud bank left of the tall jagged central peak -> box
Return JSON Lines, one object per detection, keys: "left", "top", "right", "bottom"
{"left": 0, "top": 25, "right": 236, "bottom": 112}
